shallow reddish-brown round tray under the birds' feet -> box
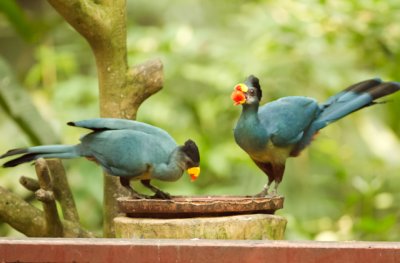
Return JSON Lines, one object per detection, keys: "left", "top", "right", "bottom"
{"left": 118, "top": 196, "right": 284, "bottom": 218}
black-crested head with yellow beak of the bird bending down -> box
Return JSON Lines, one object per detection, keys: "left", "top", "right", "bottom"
{"left": 181, "top": 140, "right": 200, "bottom": 182}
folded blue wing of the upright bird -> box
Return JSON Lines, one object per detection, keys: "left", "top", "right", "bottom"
{"left": 258, "top": 96, "right": 320, "bottom": 147}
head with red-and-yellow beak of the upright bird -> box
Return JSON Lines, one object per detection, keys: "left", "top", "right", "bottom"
{"left": 231, "top": 75, "right": 262, "bottom": 105}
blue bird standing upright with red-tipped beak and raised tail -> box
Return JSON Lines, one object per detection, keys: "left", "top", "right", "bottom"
{"left": 231, "top": 75, "right": 400, "bottom": 197}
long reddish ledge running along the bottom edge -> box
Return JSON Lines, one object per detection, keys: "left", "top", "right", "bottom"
{"left": 0, "top": 238, "right": 400, "bottom": 263}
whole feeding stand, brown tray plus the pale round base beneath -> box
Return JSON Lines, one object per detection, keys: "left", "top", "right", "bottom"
{"left": 114, "top": 196, "right": 287, "bottom": 240}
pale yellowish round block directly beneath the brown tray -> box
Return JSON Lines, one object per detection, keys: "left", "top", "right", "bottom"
{"left": 114, "top": 214, "right": 287, "bottom": 240}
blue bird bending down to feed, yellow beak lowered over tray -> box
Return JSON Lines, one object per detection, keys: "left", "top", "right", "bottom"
{"left": 0, "top": 118, "right": 200, "bottom": 199}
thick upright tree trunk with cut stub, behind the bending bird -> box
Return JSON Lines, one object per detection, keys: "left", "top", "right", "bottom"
{"left": 48, "top": 0, "right": 163, "bottom": 237}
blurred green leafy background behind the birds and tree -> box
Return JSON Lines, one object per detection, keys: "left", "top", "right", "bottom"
{"left": 0, "top": 0, "right": 400, "bottom": 241}
